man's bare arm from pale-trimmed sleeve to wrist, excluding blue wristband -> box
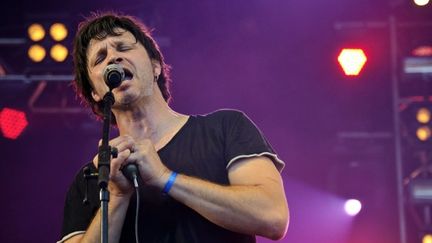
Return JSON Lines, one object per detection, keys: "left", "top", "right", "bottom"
{"left": 156, "top": 156, "right": 289, "bottom": 240}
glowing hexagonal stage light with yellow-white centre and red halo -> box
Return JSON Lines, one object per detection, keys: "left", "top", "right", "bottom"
{"left": 338, "top": 49, "right": 367, "bottom": 76}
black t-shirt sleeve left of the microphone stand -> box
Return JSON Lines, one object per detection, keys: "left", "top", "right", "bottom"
{"left": 58, "top": 164, "right": 99, "bottom": 243}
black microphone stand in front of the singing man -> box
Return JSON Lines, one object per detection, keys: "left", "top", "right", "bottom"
{"left": 98, "top": 89, "right": 117, "bottom": 243}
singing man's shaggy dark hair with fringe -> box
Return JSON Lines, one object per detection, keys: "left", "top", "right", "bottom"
{"left": 73, "top": 12, "right": 171, "bottom": 121}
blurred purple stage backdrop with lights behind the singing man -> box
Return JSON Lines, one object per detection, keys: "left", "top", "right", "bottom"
{"left": 0, "top": 0, "right": 432, "bottom": 243}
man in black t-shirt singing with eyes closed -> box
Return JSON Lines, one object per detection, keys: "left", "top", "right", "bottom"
{"left": 59, "top": 13, "right": 289, "bottom": 243}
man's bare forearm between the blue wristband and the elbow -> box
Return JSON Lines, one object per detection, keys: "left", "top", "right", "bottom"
{"left": 158, "top": 175, "right": 288, "bottom": 239}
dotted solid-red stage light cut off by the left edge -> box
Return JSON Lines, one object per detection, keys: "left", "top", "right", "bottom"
{"left": 0, "top": 108, "right": 28, "bottom": 139}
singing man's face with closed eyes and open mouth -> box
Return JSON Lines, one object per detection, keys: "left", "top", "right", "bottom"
{"left": 87, "top": 28, "right": 161, "bottom": 108}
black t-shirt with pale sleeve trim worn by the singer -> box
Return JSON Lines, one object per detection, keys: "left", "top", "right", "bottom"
{"left": 60, "top": 110, "right": 284, "bottom": 243}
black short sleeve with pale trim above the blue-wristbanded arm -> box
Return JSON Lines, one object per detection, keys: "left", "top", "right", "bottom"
{"left": 225, "top": 111, "right": 285, "bottom": 171}
